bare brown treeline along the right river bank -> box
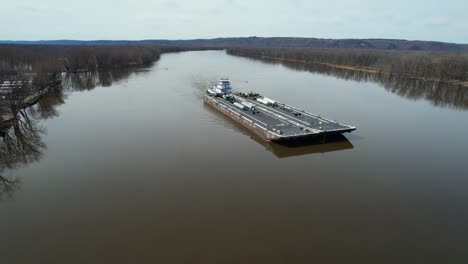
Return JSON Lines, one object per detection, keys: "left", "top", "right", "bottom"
{"left": 228, "top": 48, "right": 468, "bottom": 82}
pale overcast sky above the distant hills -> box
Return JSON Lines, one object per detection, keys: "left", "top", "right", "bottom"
{"left": 0, "top": 0, "right": 468, "bottom": 43}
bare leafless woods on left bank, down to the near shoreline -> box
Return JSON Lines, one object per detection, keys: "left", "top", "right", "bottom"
{"left": 0, "top": 45, "right": 194, "bottom": 98}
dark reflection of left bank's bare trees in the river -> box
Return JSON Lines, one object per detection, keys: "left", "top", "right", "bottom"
{"left": 0, "top": 68, "right": 146, "bottom": 197}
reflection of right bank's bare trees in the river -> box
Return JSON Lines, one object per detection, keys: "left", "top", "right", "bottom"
{"left": 249, "top": 59, "right": 468, "bottom": 109}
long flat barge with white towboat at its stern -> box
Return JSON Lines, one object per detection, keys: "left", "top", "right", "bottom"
{"left": 203, "top": 79, "right": 356, "bottom": 142}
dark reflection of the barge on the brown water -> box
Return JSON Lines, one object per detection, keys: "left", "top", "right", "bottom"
{"left": 204, "top": 105, "right": 354, "bottom": 159}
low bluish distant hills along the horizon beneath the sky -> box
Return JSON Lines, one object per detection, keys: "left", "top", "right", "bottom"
{"left": 0, "top": 37, "right": 468, "bottom": 52}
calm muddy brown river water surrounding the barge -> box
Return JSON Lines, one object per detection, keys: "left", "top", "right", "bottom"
{"left": 0, "top": 51, "right": 468, "bottom": 264}
